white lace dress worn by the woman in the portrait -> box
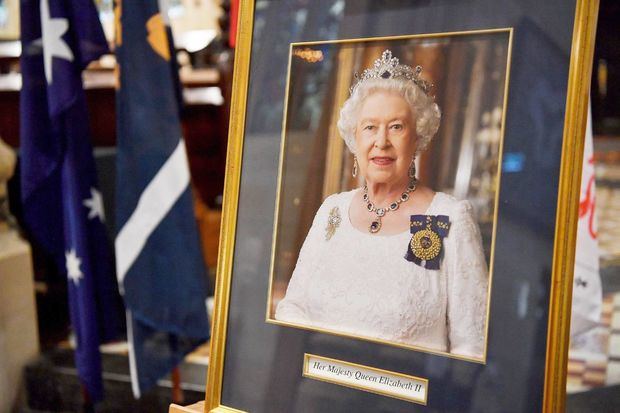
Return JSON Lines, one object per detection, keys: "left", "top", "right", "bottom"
{"left": 275, "top": 190, "right": 488, "bottom": 358}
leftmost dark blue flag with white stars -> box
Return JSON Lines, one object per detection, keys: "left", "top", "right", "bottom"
{"left": 20, "top": 0, "right": 122, "bottom": 401}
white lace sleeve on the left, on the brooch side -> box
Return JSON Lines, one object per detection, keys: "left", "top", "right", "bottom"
{"left": 275, "top": 197, "right": 331, "bottom": 324}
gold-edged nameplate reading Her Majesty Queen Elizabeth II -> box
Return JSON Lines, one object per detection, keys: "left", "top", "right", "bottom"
{"left": 303, "top": 353, "right": 428, "bottom": 405}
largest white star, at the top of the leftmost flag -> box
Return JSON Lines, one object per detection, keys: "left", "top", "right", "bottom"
{"left": 41, "top": 0, "right": 73, "bottom": 85}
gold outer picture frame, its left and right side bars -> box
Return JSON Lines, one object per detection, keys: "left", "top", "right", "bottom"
{"left": 204, "top": 0, "right": 598, "bottom": 413}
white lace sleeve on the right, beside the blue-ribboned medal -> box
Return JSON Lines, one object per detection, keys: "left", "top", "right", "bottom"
{"left": 446, "top": 201, "right": 489, "bottom": 358}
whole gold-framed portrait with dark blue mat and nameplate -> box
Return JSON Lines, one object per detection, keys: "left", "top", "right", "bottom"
{"left": 199, "top": 0, "right": 598, "bottom": 413}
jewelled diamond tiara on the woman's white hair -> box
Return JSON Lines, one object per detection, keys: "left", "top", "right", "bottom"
{"left": 350, "top": 49, "right": 433, "bottom": 96}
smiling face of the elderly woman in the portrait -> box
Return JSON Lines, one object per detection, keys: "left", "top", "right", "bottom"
{"left": 355, "top": 91, "right": 417, "bottom": 185}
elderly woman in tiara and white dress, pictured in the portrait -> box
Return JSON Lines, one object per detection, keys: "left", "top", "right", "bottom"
{"left": 275, "top": 50, "right": 488, "bottom": 358}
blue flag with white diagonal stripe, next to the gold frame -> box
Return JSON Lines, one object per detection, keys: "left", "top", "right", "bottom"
{"left": 116, "top": 0, "right": 209, "bottom": 397}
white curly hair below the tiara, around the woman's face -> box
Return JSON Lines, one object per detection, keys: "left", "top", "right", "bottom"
{"left": 337, "top": 78, "right": 441, "bottom": 155}
